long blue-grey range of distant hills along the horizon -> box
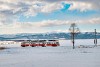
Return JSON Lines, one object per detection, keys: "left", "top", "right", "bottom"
{"left": 0, "top": 32, "right": 100, "bottom": 40}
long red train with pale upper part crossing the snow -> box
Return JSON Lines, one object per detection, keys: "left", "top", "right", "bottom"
{"left": 21, "top": 40, "right": 60, "bottom": 47}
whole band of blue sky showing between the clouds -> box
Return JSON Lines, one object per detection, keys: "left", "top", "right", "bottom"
{"left": 19, "top": 3, "right": 97, "bottom": 22}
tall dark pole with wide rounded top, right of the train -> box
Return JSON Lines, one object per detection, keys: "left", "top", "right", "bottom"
{"left": 69, "top": 23, "right": 80, "bottom": 49}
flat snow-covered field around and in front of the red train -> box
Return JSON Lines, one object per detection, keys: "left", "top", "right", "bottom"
{"left": 0, "top": 39, "right": 100, "bottom": 67}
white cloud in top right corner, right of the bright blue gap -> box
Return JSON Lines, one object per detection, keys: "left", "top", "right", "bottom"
{"left": 38, "top": 0, "right": 100, "bottom": 11}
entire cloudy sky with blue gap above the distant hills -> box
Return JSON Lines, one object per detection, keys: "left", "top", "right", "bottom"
{"left": 0, "top": 0, "right": 100, "bottom": 34}
